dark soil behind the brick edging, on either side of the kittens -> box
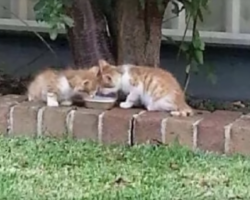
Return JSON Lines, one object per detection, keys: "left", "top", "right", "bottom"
{"left": 0, "top": 72, "right": 250, "bottom": 113}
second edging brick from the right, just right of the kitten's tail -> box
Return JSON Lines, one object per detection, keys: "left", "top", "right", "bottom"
{"left": 197, "top": 111, "right": 241, "bottom": 153}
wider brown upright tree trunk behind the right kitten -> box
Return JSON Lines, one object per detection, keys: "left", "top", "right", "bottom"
{"left": 114, "top": 0, "right": 169, "bottom": 67}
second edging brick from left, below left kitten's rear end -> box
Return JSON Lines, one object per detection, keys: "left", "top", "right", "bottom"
{"left": 10, "top": 102, "right": 43, "bottom": 136}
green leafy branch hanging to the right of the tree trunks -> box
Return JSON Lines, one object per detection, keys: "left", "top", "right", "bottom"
{"left": 171, "top": 0, "right": 216, "bottom": 90}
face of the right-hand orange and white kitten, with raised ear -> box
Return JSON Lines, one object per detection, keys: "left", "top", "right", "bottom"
{"left": 98, "top": 60, "right": 121, "bottom": 95}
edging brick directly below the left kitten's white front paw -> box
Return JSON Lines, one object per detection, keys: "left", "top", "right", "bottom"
{"left": 42, "top": 107, "right": 73, "bottom": 137}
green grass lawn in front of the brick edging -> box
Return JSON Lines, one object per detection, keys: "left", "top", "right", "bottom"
{"left": 0, "top": 138, "right": 250, "bottom": 200}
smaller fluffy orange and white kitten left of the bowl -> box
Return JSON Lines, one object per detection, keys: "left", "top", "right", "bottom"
{"left": 28, "top": 67, "right": 98, "bottom": 106}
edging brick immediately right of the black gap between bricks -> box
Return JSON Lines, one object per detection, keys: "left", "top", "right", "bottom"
{"left": 134, "top": 112, "right": 170, "bottom": 144}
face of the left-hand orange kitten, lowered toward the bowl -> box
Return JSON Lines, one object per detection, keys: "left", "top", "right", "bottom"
{"left": 74, "top": 66, "right": 99, "bottom": 97}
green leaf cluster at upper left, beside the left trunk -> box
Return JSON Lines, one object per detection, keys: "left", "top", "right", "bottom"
{"left": 34, "top": 0, "right": 74, "bottom": 40}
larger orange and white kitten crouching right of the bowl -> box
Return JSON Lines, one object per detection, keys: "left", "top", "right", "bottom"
{"left": 98, "top": 60, "right": 194, "bottom": 116}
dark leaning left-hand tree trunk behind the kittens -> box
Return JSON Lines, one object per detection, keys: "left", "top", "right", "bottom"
{"left": 66, "top": 0, "right": 114, "bottom": 68}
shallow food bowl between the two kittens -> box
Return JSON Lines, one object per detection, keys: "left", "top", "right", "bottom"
{"left": 84, "top": 96, "right": 117, "bottom": 110}
